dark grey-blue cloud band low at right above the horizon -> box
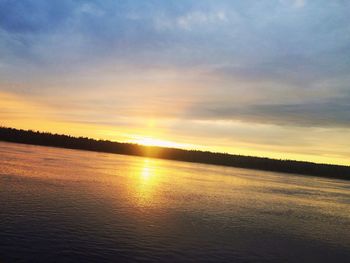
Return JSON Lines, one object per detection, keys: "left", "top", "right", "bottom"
{"left": 187, "top": 97, "right": 350, "bottom": 128}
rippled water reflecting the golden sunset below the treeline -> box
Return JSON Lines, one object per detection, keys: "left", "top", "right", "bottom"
{"left": 0, "top": 143, "right": 350, "bottom": 263}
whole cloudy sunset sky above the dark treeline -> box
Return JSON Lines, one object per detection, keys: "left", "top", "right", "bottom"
{"left": 0, "top": 0, "right": 350, "bottom": 165}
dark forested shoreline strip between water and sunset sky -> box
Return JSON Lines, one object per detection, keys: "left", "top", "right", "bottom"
{"left": 0, "top": 127, "right": 350, "bottom": 179}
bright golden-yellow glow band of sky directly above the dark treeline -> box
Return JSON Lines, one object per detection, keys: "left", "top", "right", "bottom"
{"left": 0, "top": 92, "right": 350, "bottom": 165}
